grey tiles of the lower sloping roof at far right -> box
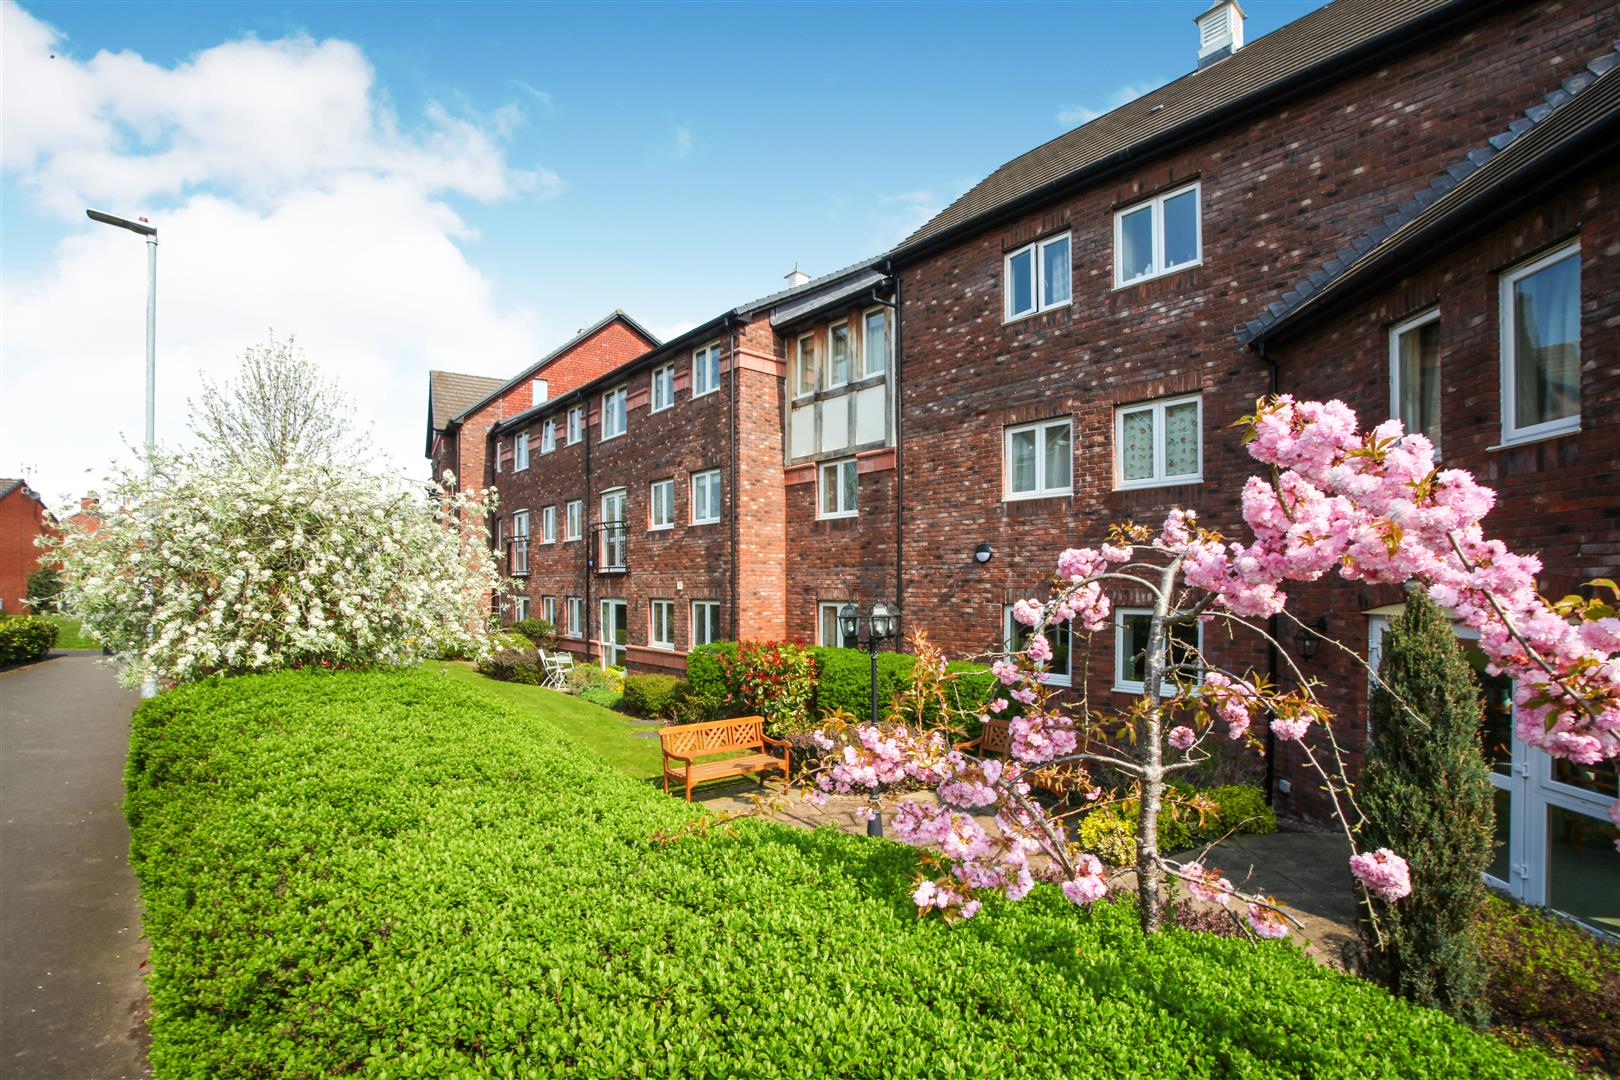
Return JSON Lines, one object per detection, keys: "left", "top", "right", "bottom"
{"left": 1238, "top": 42, "right": 1620, "bottom": 343}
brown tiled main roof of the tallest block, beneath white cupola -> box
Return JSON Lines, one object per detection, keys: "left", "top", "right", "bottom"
{"left": 894, "top": 0, "right": 1494, "bottom": 257}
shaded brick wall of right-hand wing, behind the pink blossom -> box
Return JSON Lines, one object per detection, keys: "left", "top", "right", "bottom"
{"left": 1273, "top": 167, "right": 1620, "bottom": 816}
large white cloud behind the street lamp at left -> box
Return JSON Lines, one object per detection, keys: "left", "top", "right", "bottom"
{"left": 0, "top": 3, "right": 561, "bottom": 497}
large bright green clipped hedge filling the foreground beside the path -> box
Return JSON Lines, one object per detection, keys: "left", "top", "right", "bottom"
{"left": 126, "top": 670, "right": 1567, "bottom": 1080}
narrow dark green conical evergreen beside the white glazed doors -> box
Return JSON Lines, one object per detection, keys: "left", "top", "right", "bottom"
{"left": 1356, "top": 591, "right": 1495, "bottom": 1027}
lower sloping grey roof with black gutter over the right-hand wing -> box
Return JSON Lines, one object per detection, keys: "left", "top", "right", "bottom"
{"left": 1238, "top": 42, "right": 1620, "bottom": 345}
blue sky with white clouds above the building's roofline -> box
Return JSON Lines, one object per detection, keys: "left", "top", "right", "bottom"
{"left": 0, "top": 0, "right": 1319, "bottom": 494}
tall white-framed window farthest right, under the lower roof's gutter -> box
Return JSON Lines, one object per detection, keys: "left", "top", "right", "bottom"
{"left": 1502, "top": 243, "right": 1581, "bottom": 444}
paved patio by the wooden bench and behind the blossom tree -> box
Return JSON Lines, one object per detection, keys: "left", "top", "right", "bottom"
{"left": 693, "top": 779, "right": 1358, "bottom": 968}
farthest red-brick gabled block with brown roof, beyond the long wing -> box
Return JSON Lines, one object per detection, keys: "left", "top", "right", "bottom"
{"left": 428, "top": 311, "right": 658, "bottom": 495}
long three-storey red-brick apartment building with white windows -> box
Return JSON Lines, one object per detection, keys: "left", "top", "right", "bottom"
{"left": 427, "top": 0, "right": 1620, "bottom": 931}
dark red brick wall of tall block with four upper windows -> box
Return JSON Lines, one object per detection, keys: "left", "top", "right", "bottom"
{"left": 901, "top": 2, "right": 1620, "bottom": 725}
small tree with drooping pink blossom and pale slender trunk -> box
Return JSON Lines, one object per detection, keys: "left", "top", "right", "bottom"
{"left": 812, "top": 397, "right": 1620, "bottom": 938}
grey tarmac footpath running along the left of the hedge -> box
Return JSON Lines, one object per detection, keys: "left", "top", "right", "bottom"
{"left": 0, "top": 653, "right": 151, "bottom": 1080}
